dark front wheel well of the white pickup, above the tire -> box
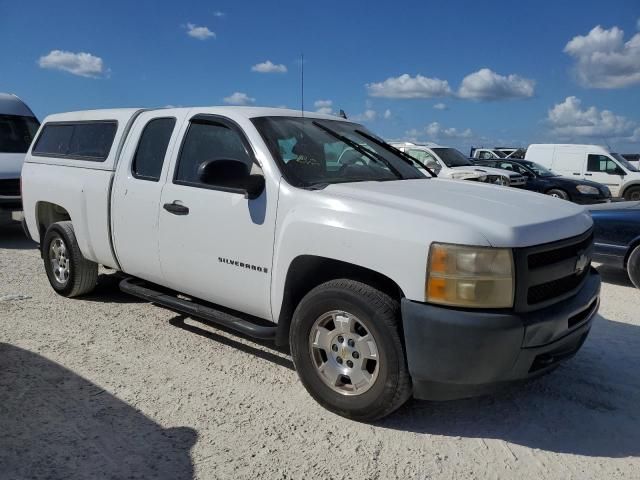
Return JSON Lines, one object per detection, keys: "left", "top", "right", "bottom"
{"left": 276, "top": 255, "right": 404, "bottom": 345}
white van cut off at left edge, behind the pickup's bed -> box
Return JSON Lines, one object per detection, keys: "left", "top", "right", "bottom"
{"left": 0, "top": 93, "right": 40, "bottom": 214}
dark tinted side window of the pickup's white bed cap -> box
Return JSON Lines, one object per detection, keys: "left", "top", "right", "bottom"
{"left": 33, "top": 120, "right": 118, "bottom": 162}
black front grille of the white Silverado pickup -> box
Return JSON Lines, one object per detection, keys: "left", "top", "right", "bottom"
{"left": 514, "top": 230, "right": 593, "bottom": 311}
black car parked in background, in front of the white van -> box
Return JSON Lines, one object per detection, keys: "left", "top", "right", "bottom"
{"left": 474, "top": 158, "right": 611, "bottom": 204}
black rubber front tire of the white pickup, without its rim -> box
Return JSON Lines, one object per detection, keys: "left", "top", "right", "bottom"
{"left": 289, "top": 279, "right": 412, "bottom": 421}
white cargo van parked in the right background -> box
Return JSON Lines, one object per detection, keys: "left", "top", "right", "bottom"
{"left": 525, "top": 143, "right": 640, "bottom": 200}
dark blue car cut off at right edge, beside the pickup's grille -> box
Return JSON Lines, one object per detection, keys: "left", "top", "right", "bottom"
{"left": 589, "top": 202, "right": 640, "bottom": 288}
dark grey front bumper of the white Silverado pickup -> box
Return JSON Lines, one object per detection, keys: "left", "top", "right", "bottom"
{"left": 402, "top": 268, "right": 600, "bottom": 400}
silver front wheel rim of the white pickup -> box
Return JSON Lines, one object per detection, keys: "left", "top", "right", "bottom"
{"left": 309, "top": 310, "right": 380, "bottom": 395}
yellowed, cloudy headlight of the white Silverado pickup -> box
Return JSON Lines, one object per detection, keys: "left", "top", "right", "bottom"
{"left": 425, "top": 243, "right": 514, "bottom": 308}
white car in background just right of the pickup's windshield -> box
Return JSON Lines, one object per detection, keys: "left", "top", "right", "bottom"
{"left": 393, "top": 142, "right": 526, "bottom": 187}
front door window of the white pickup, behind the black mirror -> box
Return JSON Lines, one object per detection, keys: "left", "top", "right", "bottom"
{"left": 174, "top": 121, "right": 253, "bottom": 186}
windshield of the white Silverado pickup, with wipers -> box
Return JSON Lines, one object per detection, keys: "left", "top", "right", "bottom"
{"left": 252, "top": 117, "right": 426, "bottom": 187}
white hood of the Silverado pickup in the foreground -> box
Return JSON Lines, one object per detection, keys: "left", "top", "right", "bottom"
{"left": 324, "top": 178, "right": 593, "bottom": 247}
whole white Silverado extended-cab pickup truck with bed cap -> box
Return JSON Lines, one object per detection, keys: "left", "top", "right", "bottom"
{"left": 22, "top": 107, "right": 600, "bottom": 420}
